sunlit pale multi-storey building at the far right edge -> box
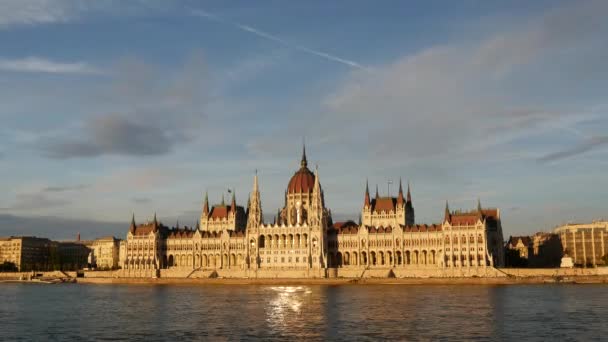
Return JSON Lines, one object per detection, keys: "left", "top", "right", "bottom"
{"left": 553, "top": 221, "right": 608, "bottom": 266}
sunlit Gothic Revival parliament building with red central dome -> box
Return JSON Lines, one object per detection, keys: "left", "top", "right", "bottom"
{"left": 120, "top": 149, "right": 504, "bottom": 278}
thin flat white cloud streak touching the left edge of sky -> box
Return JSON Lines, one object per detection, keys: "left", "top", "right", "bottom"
{"left": 0, "top": 57, "right": 103, "bottom": 75}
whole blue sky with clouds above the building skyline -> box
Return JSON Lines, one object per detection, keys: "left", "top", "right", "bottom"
{"left": 0, "top": 0, "right": 608, "bottom": 237}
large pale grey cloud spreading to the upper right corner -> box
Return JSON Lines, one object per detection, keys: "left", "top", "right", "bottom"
{"left": 319, "top": 2, "right": 608, "bottom": 160}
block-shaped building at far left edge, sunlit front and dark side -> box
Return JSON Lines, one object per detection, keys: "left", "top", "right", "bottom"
{"left": 0, "top": 236, "right": 54, "bottom": 271}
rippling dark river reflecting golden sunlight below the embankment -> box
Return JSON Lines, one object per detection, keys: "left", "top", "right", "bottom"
{"left": 0, "top": 284, "right": 608, "bottom": 341}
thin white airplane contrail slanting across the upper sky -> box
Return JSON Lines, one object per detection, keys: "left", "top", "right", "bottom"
{"left": 192, "top": 10, "right": 369, "bottom": 70}
